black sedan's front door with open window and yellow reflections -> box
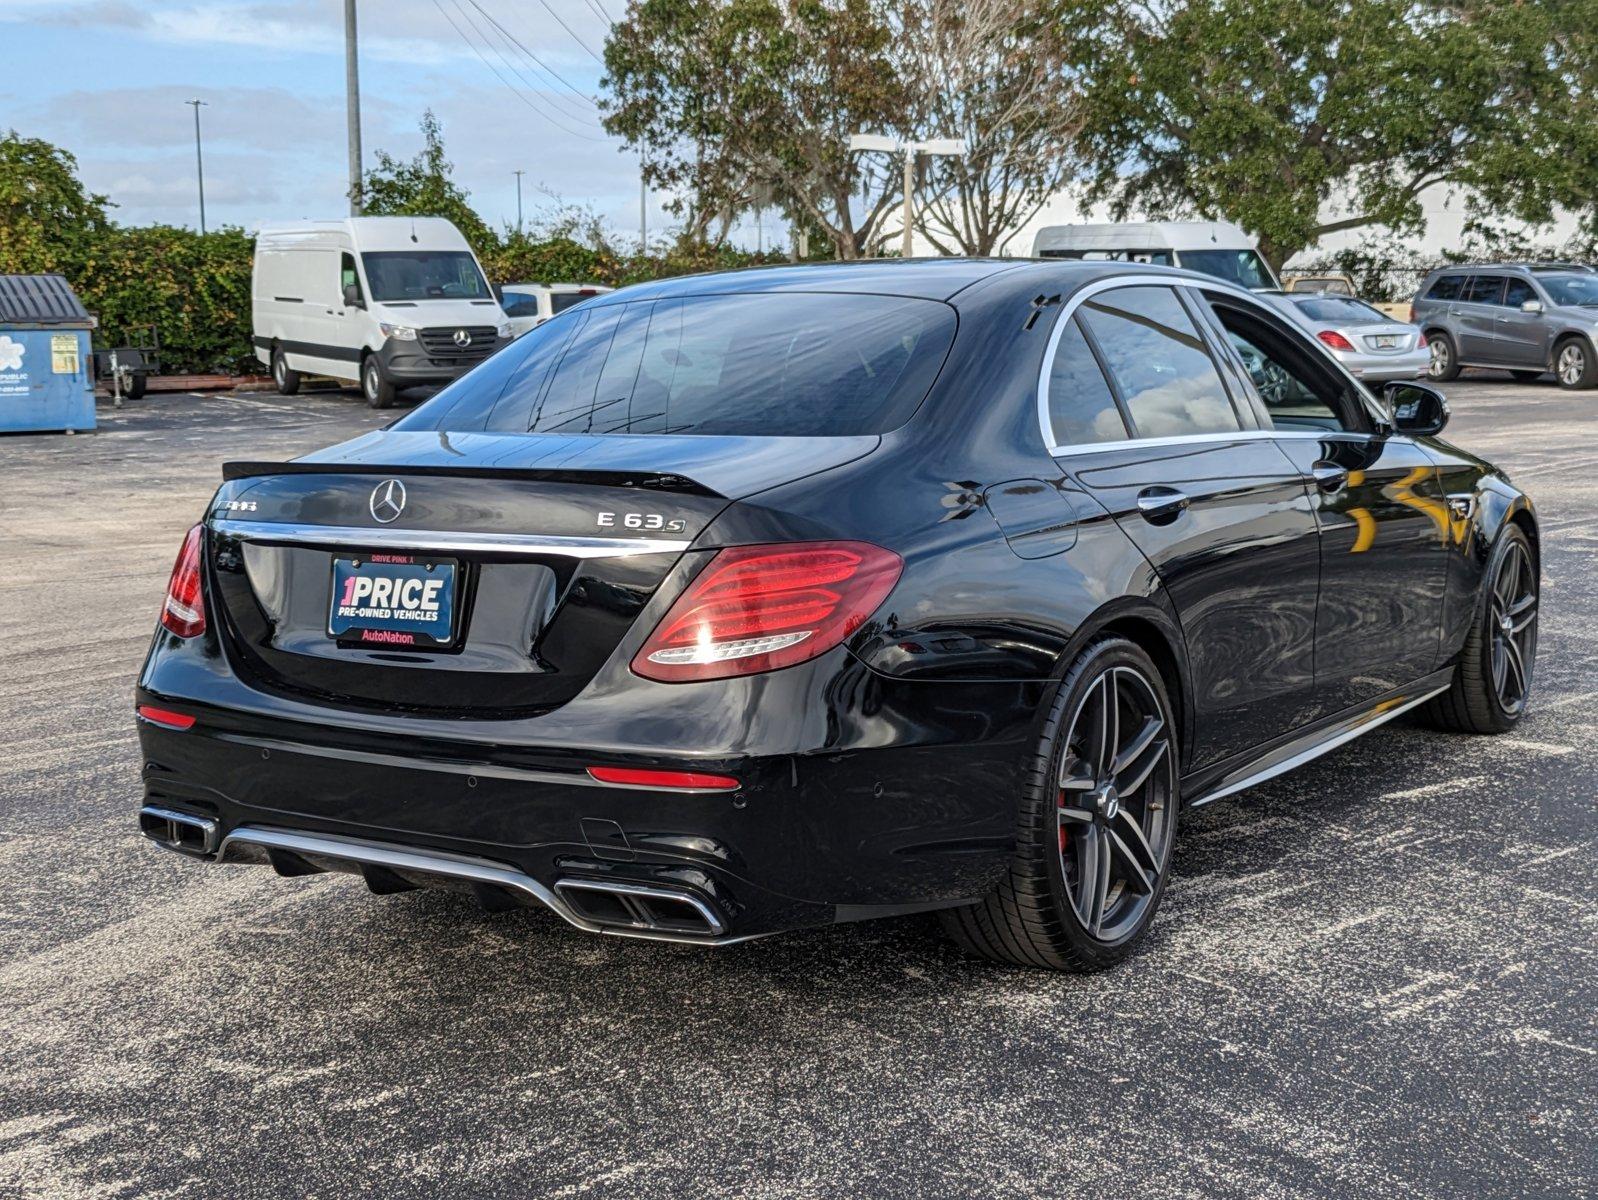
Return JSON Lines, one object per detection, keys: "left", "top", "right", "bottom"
{"left": 1208, "top": 292, "right": 1449, "bottom": 716}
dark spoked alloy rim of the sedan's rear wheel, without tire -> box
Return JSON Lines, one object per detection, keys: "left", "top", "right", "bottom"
{"left": 1058, "top": 666, "right": 1176, "bottom": 943}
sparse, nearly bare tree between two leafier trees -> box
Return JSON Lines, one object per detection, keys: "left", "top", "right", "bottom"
{"left": 901, "top": 0, "right": 1080, "bottom": 254}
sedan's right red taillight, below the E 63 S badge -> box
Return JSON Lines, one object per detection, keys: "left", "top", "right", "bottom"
{"left": 633, "top": 542, "right": 904, "bottom": 684}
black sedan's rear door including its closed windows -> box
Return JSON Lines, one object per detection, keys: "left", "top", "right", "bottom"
{"left": 1047, "top": 284, "right": 1320, "bottom": 767}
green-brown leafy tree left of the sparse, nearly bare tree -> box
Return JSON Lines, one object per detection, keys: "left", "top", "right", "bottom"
{"left": 604, "top": 0, "right": 912, "bottom": 259}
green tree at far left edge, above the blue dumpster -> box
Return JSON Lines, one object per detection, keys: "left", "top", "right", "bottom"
{"left": 0, "top": 129, "right": 107, "bottom": 275}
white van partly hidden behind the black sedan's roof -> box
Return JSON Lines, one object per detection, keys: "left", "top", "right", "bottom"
{"left": 1032, "top": 221, "right": 1282, "bottom": 291}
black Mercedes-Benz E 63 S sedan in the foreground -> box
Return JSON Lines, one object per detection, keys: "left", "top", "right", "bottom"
{"left": 136, "top": 259, "right": 1539, "bottom": 970}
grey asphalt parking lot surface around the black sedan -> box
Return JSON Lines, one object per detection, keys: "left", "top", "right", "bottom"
{"left": 0, "top": 377, "right": 1598, "bottom": 1198}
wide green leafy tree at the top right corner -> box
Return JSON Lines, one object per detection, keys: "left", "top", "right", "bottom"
{"left": 1056, "top": 0, "right": 1598, "bottom": 265}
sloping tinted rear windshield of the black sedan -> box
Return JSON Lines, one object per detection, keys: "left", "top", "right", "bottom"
{"left": 396, "top": 292, "right": 956, "bottom": 438}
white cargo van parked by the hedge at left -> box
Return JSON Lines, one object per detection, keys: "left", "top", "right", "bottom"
{"left": 251, "top": 217, "right": 511, "bottom": 409}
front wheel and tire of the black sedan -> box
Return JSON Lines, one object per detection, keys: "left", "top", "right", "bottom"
{"left": 1427, "top": 524, "right": 1539, "bottom": 733}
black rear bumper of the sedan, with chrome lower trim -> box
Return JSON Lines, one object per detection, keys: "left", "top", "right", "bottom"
{"left": 139, "top": 662, "right": 1036, "bottom": 944}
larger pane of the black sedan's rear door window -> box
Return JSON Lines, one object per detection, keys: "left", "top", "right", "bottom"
{"left": 1079, "top": 286, "right": 1242, "bottom": 438}
